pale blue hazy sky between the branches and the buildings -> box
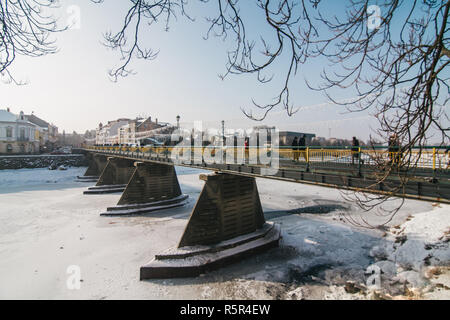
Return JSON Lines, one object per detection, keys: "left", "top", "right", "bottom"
{"left": 0, "top": 0, "right": 442, "bottom": 140}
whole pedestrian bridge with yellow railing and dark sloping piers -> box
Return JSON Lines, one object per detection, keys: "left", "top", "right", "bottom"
{"left": 79, "top": 146, "right": 450, "bottom": 279}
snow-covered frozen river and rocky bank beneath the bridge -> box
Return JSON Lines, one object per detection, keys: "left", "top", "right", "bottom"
{"left": 0, "top": 168, "right": 450, "bottom": 299}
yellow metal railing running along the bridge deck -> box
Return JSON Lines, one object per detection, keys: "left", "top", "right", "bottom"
{"left": 88, "top": 146, "right": 450, "bottom": 170}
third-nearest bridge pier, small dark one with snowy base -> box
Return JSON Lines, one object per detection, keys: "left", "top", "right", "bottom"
{"left": 84, "top": 157, "right": 134, "bottom": 194}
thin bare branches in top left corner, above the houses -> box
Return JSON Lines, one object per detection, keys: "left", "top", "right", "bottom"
{"left": 0, "top": 0, "right": 64, "bottom": 84}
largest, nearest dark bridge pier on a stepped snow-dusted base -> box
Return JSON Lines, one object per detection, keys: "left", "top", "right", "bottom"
{"left": 140, "top": 173, "right": 280, "bottom": 280}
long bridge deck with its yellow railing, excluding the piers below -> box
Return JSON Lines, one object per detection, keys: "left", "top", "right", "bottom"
{"left": 85, "top": 147, "right": 450, "bottom": 203}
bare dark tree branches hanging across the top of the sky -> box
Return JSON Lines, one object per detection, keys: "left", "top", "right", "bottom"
{"left": 0, "top": 0, "right": 450, "bottom": 225}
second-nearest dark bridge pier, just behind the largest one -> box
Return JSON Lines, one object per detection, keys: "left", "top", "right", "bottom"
{"left": 101, "top": 162, "right": 188, "bottom": 216}
